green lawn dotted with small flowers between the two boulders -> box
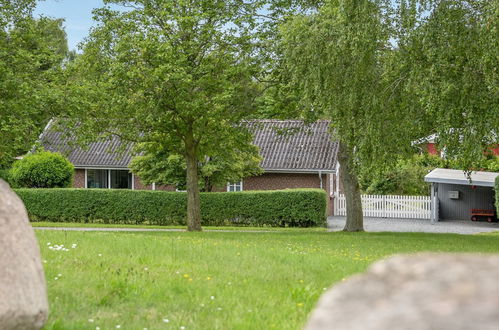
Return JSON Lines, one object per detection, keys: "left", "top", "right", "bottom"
{"left": 36, "top": 230, "right": 499, "bottom": 329}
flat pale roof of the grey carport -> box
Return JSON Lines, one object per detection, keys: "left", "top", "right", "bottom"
{"left": 424, "top": 168, "right": 499, "bottom": 187}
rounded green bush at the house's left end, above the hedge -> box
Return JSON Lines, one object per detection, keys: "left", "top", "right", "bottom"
{"left": 10, "top": 151, "right": 74, "bottom": 188}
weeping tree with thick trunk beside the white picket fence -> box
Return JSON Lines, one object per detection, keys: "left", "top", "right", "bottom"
{"left": 282, "top": 0, "right": 417, "bottom": 231}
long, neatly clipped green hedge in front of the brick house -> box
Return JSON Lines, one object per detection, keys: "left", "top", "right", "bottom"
{"left": 15, "top": 189, "right": 326, "bottom": 227}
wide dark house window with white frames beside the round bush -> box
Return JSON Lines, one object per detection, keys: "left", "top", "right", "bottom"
{"left": 87, "top": 169, "right": 133, "bottom": 189}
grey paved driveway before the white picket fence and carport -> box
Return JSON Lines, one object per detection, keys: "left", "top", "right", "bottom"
{"left": 328, "top": 217, "right": 499, "bottom": 234}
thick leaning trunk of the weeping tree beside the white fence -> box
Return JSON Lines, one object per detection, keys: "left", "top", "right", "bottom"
{"left": 338, "top": 142, "right": 364, "bottom": 231}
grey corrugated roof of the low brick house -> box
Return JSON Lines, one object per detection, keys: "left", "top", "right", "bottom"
{"left": 40, "top": 120, "right": 338, "bottom": 172}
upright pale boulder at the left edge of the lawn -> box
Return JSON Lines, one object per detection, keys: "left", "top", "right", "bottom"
{"left": 0, "top": 179, "right": 48, "bottom": 330}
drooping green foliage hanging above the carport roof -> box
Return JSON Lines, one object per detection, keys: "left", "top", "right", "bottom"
{"left": 400, "top": 0, "right": 499, "bottom": 170}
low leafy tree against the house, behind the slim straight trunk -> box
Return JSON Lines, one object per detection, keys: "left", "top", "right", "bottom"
{"left": 130, "top": 141, "right": 261, "bottom": 192}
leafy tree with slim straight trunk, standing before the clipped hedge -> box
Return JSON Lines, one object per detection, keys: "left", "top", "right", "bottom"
{"left": 71, "top": 0, "right": 268, "bottom": 230}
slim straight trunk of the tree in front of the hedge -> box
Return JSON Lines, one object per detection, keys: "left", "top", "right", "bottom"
{"left": 185, "top": 132, "right": 201, "bottom": 231}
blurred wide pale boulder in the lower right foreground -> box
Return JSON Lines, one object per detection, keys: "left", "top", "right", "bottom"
{"left": 306, "top": 254, "right": 499, "bottom": 330}
